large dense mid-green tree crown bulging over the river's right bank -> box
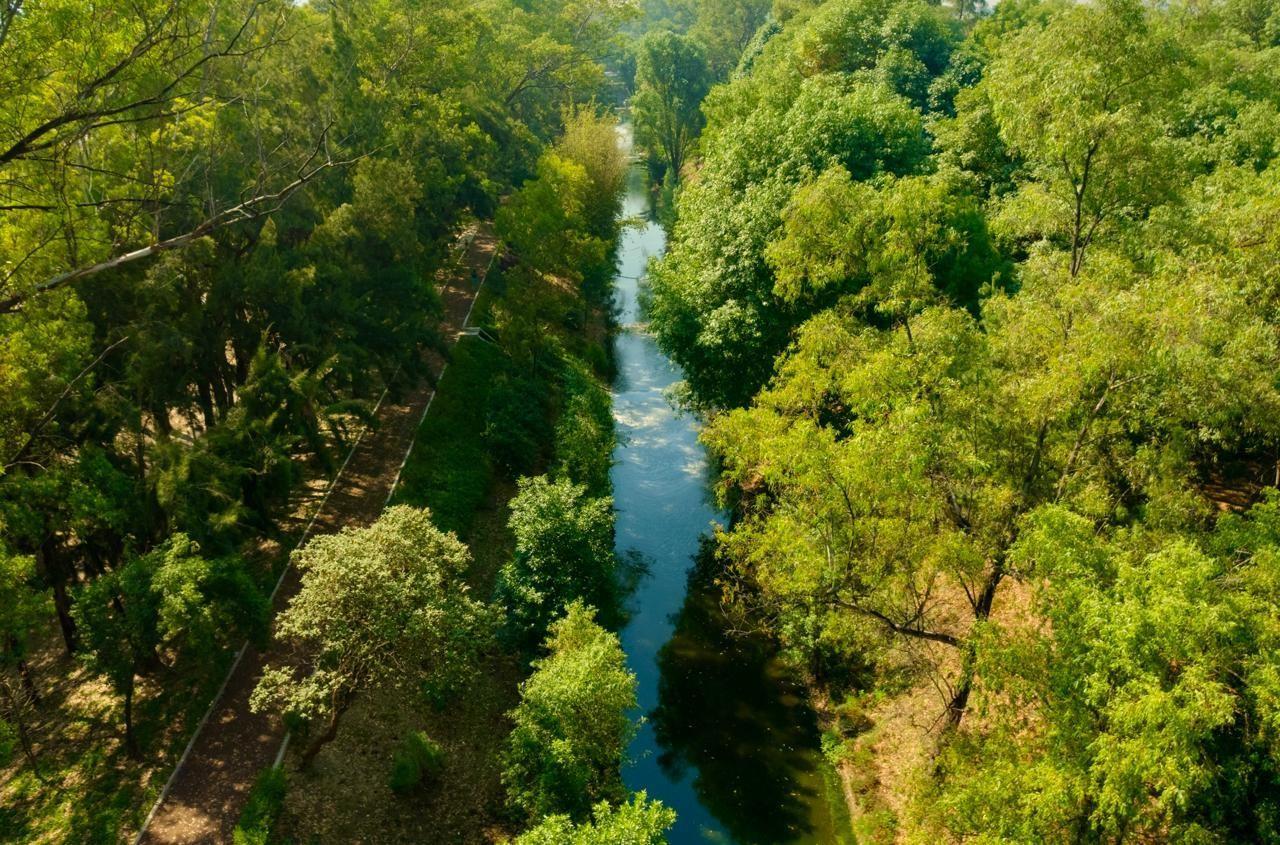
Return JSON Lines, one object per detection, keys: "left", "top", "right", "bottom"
{"left": 648, "top": 0, "right": 947, "bottom": 407}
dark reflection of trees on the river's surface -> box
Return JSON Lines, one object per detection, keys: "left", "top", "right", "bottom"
{"left": 650, "top": 545, "right": 818, "bottom": 845}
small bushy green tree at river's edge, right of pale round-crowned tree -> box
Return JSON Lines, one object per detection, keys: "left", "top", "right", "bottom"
{"left": 497, "top": 476, "right": 617, "bottom": 639}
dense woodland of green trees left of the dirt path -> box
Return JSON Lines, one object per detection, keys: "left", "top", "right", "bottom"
{"left": 0, "top": 0, "right": 635, "bottom": 841}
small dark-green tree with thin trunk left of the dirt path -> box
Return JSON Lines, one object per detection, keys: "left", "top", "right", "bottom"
{"left": 73, "top": 534, "right": 266, "bottom": 757}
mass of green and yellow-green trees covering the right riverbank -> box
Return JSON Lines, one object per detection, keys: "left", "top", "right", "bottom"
{"left": 650, "top": 0, "right": 1280, "bottom": 842}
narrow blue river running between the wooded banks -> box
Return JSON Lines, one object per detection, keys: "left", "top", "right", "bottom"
{"left": 613, "top": 129, "right": 851, "bottom": 845}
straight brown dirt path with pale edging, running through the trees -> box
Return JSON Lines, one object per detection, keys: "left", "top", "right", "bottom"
{"left": 137, "top": 225, "right": 497, "bottom": 845}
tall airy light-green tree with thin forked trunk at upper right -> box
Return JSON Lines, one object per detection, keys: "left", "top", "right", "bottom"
{"left": 986, "top": 0, "right": 1187, "bottom": 275}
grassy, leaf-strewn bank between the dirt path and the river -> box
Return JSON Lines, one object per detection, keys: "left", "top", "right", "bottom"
{"left": 276, "top": 258, "right": 613, "bottom": 844}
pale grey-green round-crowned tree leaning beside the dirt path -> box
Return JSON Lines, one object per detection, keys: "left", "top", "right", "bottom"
{"left": 252, "top": 507, "right": 494, "bottom": 766}
